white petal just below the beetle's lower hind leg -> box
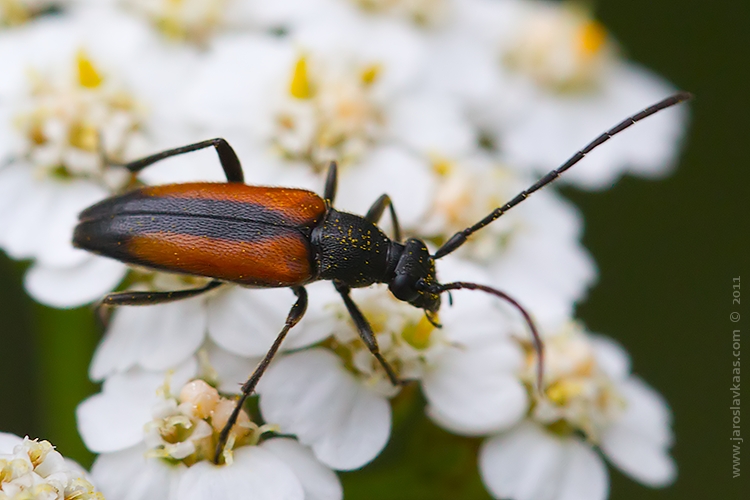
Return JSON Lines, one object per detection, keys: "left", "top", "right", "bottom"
{"left": 90, "top": 297, "right": 206, "bottom": 380}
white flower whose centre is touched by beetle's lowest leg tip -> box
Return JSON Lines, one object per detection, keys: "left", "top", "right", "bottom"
{"left": 78, "top": 362, "right": 342, "bottom": 500}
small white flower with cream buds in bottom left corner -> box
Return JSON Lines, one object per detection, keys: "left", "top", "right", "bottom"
{"left": 0, "top": 433, "right": 104, "bottom": 500}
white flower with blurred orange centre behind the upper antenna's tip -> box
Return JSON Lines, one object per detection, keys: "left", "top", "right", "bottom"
{"left": 433, "top": 0, "right": 687, "bottom": 188}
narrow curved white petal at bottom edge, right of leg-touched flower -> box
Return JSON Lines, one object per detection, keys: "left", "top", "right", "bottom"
{"left": 261, "top": 438, "right": 344, "bottom": 500}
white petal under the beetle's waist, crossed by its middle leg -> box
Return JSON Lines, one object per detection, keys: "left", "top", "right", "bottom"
{"left": 208, "top": 287, "right": 304, "bottom": 356}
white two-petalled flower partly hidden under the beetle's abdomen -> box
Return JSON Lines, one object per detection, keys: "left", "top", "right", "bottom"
{"left": 89, "top": 273, "right": 334, "bottom": 380}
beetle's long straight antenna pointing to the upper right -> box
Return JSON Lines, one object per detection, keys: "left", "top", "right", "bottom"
{"left": 433, "top": 92, "right": 693, "bottom": 259}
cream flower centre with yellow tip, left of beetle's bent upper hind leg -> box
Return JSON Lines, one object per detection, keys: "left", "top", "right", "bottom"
{"left": 14, "top": 50, "right": 144, "bottom": 190}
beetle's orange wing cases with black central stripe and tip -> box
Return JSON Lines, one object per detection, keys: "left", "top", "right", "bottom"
{"left": 73, "top": 183, "right": 325, "bottom": 287}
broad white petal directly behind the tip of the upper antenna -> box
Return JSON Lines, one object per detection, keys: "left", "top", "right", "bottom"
{"left": 499, "top": 62, "right": 687, "bottom": 189}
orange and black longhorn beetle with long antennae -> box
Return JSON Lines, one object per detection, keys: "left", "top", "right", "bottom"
{"left": 73, "top": 92, "right": 691, "bottom": 463}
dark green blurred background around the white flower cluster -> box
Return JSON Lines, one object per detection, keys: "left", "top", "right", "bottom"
{"left": 0, "top": 0, "right": 750, "bottom": 500}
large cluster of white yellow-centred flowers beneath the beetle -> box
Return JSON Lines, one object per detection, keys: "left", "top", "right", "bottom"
{"left": 0, "top": 0, "right": 686, "bottom": 500}
